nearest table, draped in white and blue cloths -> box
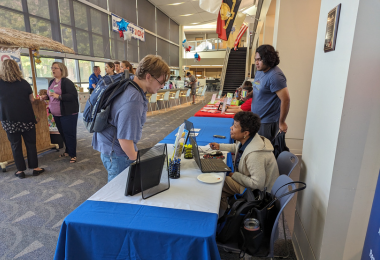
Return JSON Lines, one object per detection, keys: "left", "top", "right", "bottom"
{"left": 54, "top": 147, "right": 230, "bottom": 260}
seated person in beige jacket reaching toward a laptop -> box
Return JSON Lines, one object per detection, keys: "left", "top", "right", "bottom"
{"left": 210, "top": 112, "right": 279, "bottom": 211}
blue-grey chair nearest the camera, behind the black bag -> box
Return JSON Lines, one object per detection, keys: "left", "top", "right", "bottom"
{"left": 268, "top": 175, "right": 296, "bottom": 257}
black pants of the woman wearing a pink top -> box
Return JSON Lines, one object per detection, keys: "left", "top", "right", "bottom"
{"left": 54, "top": 114, "right": 78, "bottom": 157}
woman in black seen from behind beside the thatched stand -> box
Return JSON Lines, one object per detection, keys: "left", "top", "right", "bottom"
{"left": 0, "top": 60, "right": 45, "bottom": 179}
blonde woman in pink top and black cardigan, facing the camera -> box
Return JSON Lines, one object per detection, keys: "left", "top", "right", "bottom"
{"left": 41, "top": 62, "right": 79, "bottom": 163}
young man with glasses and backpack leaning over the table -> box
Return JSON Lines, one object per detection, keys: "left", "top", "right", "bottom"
{"left": 92, "top": 55, "right": 170, "bottom": 182}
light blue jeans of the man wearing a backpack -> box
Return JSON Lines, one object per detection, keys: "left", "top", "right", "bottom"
{"left": 100, "top": 153, "right": 133, "bottom": 182}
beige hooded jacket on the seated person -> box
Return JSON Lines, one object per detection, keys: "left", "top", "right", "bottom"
{"left": 220, "top": 134, "right": 279, "bottom": 192}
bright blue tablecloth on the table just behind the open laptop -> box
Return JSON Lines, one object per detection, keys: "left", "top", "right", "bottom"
{"left": 160, "top": 117, "right": 234, "bottom": 145}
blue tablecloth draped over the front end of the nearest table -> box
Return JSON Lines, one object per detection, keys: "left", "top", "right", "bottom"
{"left": 54, "top": 200, "right": 220, "bottom": 260}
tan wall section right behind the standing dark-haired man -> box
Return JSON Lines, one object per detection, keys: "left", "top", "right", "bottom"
{"left": 274, "top": 0, "right": 321, "bottom": 154}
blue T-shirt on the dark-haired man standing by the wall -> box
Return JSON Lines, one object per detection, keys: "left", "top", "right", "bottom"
{"left": 252, "top": 66, "right": 286, "bottom": 124}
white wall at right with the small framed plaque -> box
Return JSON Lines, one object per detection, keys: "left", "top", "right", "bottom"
{"left": 296, "top": 0, "right": 380, "bottom": 260}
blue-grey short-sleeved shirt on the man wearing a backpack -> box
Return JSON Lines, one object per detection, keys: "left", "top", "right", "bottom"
{"left": 92, "top": 84, "right": 148, "bottom": 156}
